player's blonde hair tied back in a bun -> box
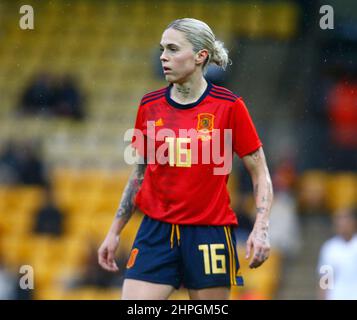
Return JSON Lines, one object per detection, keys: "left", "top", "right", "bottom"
{"left": 166, "top": 18, "right": 232, "bottom": 72}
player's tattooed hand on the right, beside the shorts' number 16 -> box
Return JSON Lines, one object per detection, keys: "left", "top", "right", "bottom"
{"left": 245, "top": 221, "right": 270, "bottom": 268}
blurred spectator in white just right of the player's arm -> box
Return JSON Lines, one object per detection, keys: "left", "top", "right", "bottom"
{"left": 270, "top": 159, "right": 301, "bottom": 258}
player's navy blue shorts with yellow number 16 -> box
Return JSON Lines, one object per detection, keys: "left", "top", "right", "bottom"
{"left": 125, "top": 216, "right": 243, "bottom": 289}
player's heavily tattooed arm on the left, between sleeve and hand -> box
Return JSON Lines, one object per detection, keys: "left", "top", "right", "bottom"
{"left": 116, "top": 164, "right": 146, "bottom": 221}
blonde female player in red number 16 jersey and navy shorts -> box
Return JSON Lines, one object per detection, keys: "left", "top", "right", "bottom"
{"left": 98, "top": 18, "right": 273, "bottom": 300}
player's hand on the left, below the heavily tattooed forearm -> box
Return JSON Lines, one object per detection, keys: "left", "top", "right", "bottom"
{"left": 98, "top": 233, "right": 119, "bottom": 272}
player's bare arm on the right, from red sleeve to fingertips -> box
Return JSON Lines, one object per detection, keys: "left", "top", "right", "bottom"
{"left": 242, "top": 148, "right": 273, "bottom": 268}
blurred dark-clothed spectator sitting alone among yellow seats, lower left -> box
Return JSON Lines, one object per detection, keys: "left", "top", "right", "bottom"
{"left": 34, "top": 187, "right": 64, "bottom": 236}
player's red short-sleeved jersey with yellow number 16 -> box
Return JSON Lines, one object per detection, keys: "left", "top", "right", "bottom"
{"left": 132, "top": 82, "right": 262, "bottom": 225}
